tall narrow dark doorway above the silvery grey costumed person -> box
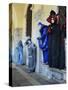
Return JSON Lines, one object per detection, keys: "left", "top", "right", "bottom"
{"left": 26, "top": 4, "right": 32, "bottom": 37}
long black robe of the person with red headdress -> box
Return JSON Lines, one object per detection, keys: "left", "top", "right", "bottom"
{"left": 48, "top": 24, "right": 61, "bottom": 68}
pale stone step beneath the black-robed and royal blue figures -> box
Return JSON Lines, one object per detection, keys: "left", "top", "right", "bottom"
{"left": 40, "top": 63, "right": 66, "bottom": 82}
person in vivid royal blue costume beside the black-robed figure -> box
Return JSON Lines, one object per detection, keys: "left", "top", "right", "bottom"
{"left": 37, "top": 22, "right": 48, "bottom": 64}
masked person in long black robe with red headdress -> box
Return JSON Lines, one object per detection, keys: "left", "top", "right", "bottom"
{"left": 47, "top": 10, "right": 61, "bottom": 68}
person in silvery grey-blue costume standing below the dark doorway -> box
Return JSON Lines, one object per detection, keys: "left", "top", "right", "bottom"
{"left": 26, "top": 39, "right": 37, "bottom": 72}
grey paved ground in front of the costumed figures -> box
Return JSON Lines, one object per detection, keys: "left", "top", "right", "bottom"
{"left": 12, "top": 65, "right": 65, "bottom": 87}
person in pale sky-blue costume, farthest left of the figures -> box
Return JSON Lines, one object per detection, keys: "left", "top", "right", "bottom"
{"left": 15, "top": 40, "right": 24, "bottom": 65}
